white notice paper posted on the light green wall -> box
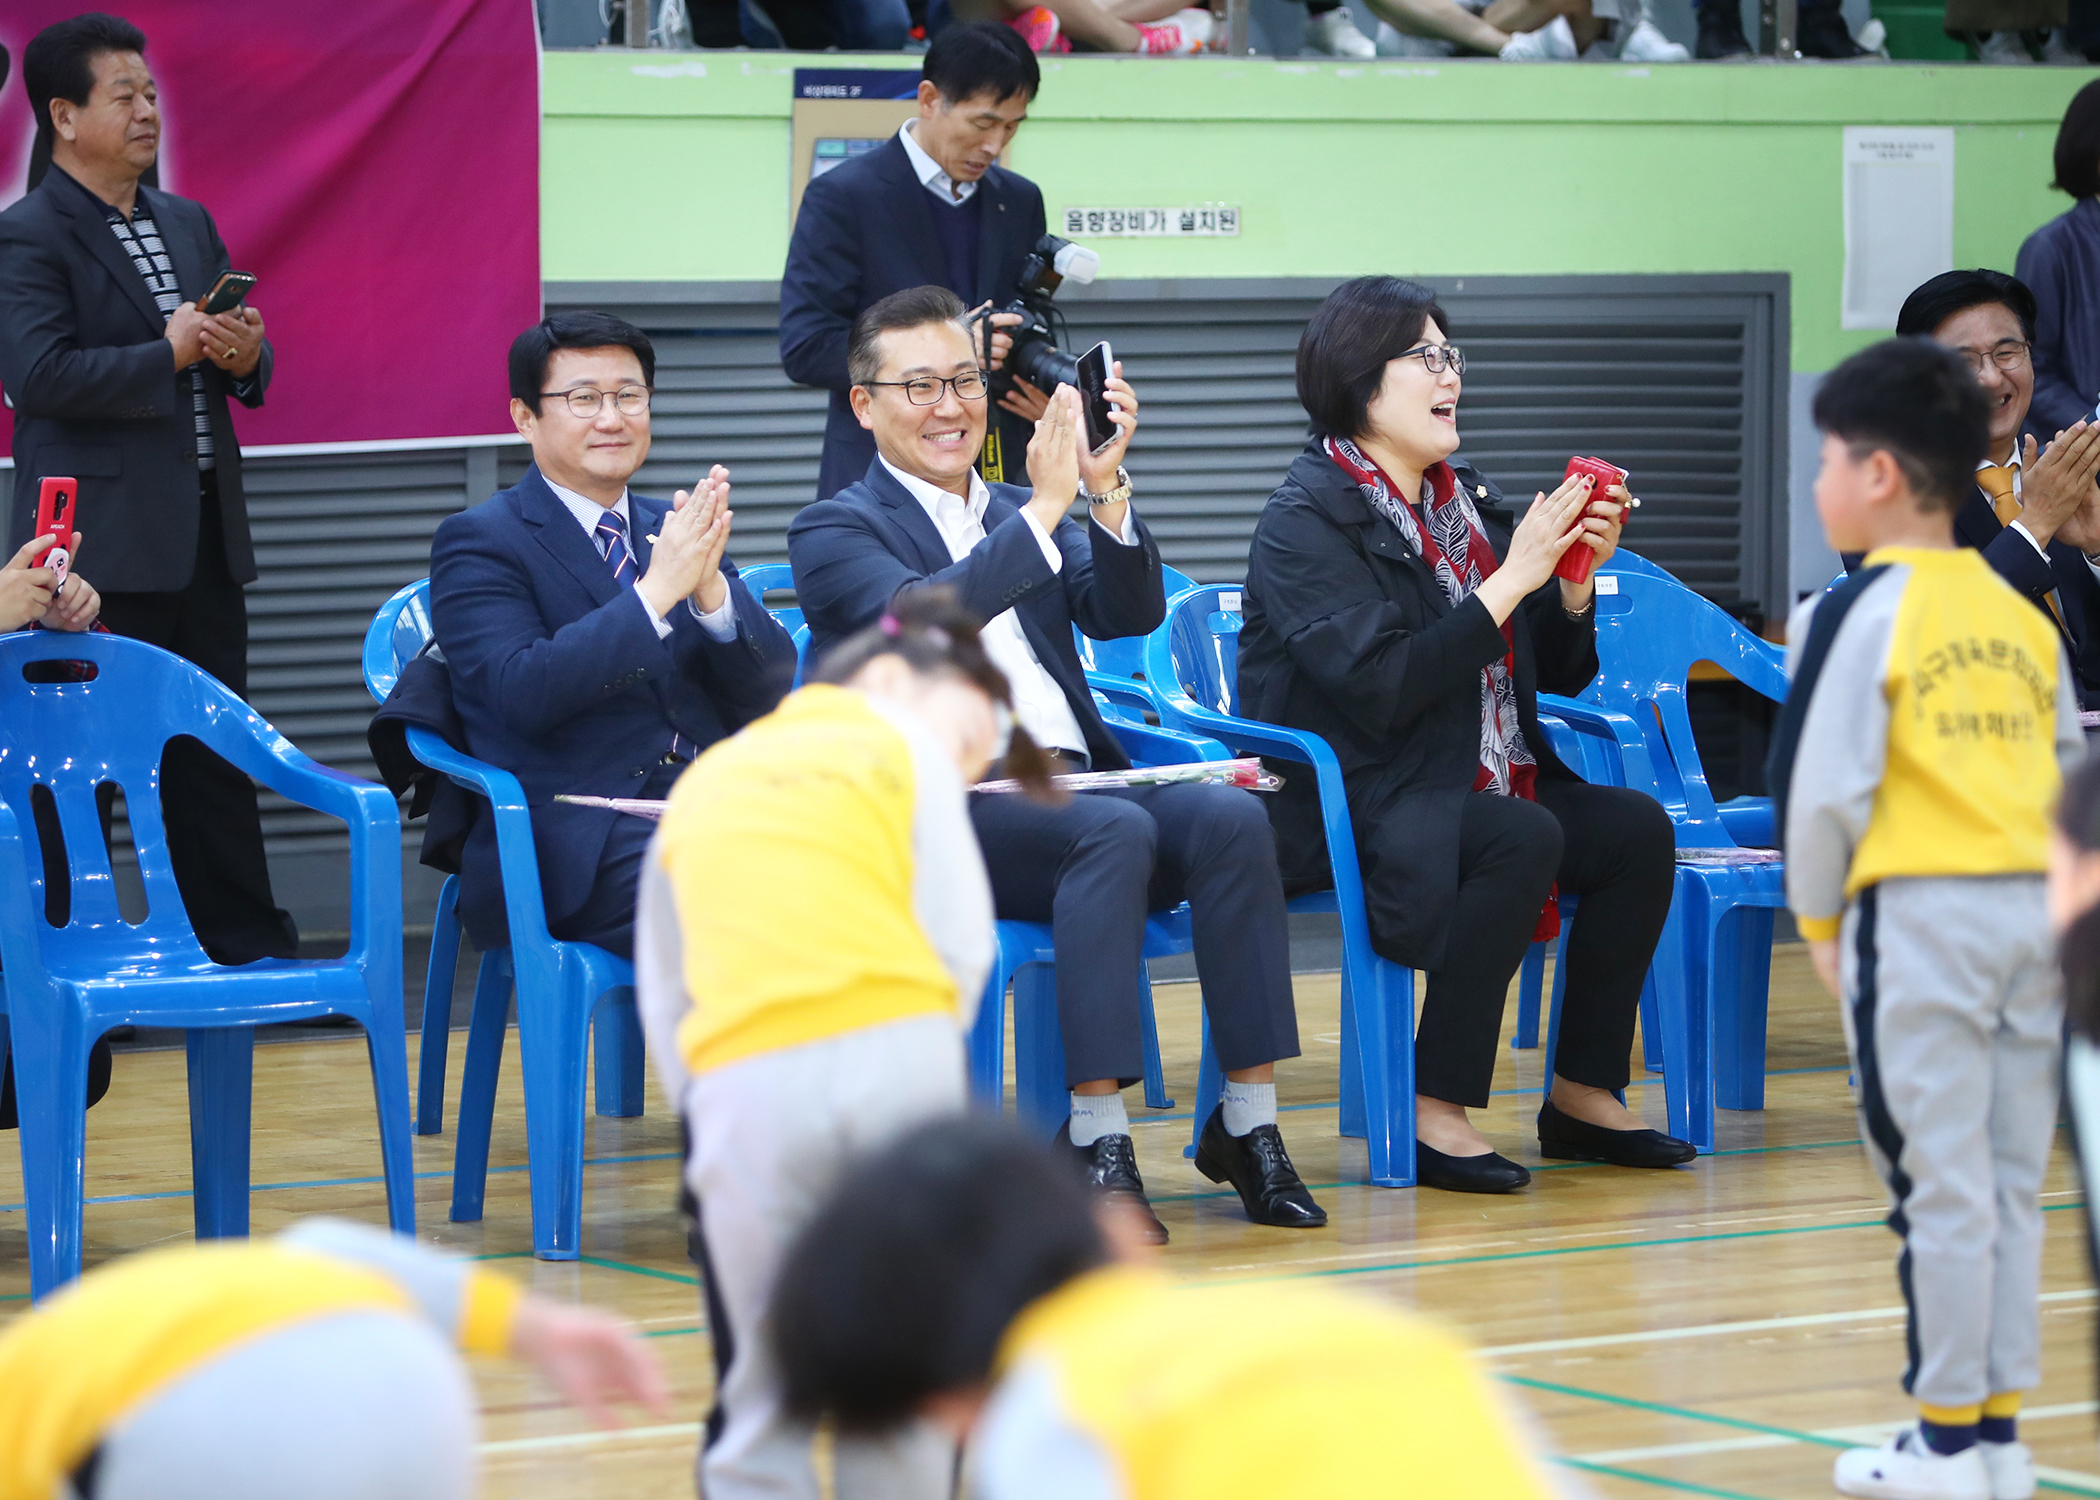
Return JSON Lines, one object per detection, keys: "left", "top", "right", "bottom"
{"left": 1840, "top": 126, "right": 1955, "bottom": 330}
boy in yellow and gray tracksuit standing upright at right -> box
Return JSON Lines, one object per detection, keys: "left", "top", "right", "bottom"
{"left": 1768, "top": 338, "right": 2083, "bottom": 1500}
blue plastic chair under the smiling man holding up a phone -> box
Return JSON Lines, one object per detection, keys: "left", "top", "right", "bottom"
{"left": 968, "top": 700, "right": 1231, "bottom": 1130}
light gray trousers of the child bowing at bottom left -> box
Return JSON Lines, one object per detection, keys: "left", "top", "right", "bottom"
{"left": 92, "top": 1311, "right": 479, "bottom": 1500}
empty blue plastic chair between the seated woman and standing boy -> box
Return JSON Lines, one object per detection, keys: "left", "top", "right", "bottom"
{"left": 1581, "top": 571, "right": 1787, "bottom": 1151}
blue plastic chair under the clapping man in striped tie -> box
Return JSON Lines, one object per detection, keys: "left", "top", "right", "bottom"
{"left": 363, "top": 578, "right": 643, "bottom": 1261}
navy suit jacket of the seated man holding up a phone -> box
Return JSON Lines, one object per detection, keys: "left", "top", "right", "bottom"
{"left": 788, "top": 458, "right": 1168, "bottom": 771}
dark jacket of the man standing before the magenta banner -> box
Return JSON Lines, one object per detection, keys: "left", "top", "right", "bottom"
{"left": 0, "top": 168, "right": 275, "bottom": 595}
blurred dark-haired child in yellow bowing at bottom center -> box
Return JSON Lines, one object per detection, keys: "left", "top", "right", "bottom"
{"left": 773, "top": 1118, "right": 1567, "bottom": 1500}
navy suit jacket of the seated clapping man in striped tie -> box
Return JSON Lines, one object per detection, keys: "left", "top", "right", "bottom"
{"left": 431, "top": 466, "right": 794, "bottom": 947}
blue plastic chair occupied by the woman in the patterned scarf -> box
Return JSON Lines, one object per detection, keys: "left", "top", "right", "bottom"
{"left": 1145, "top": 584, "right": 1415, "bottom": 1187}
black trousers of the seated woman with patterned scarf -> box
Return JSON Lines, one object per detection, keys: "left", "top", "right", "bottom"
{"left": 1415, "top": 779, "right": 1676, "bottom": 1109}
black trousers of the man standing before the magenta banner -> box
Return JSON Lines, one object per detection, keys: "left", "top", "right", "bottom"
{"left": 103, "top": 471, "right": 298, "bottom": 964}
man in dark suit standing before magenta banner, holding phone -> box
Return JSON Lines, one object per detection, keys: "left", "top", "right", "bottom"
{"left": 0, "top": 13, "right": 298, "bottom": 964}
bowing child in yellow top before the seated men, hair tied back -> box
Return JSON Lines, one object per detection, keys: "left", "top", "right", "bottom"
{"left": 634, "top": 590, "right": 1046, "bottom": 1500}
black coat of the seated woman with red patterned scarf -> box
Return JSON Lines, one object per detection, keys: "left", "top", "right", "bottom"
{"left": 1239, "top": 441, "right": 1596, "bottom": 968}
